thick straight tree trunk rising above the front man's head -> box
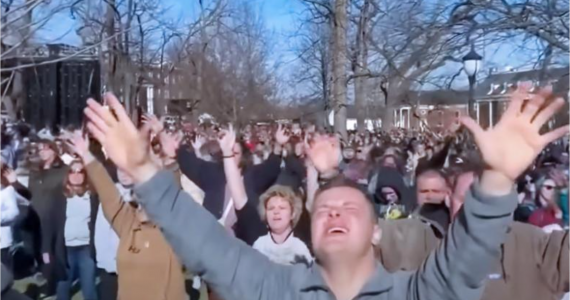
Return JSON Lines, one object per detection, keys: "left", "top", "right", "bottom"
{"left": 332, "top": 0, "right": 348, "bottom": 139}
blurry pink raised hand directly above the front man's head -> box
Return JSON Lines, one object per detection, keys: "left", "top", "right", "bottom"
{"left": 305, "top": 135, "right": 341, "bottom": 174}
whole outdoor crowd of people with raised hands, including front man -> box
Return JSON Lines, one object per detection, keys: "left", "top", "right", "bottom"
{"left": 0, "top": 85, "right": 570, "bottom": 300}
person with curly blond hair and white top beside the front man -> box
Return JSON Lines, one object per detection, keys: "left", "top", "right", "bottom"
{"left": 253, "top": 185, "right": 313, "bottom": 265}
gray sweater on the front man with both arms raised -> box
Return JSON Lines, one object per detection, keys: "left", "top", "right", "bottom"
{"left": 135, "top": 171, "right": 517, "bottom": 300}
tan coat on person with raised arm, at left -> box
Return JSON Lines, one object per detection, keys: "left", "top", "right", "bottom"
{"left": 86, "top": 162, "right": 187, "bottom": 300}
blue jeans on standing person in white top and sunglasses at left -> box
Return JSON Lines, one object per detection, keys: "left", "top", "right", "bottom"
{"left": 56, "top": 246, "right": 97, "bottom": 300}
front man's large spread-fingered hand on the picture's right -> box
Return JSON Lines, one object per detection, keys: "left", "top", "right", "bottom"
{"left": 461, "top": 84, "right": 570, "bottom": 192}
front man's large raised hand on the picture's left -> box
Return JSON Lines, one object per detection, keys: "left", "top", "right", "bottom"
{"left": 85, "top": 93, "right": 158, "bottom": 182}
